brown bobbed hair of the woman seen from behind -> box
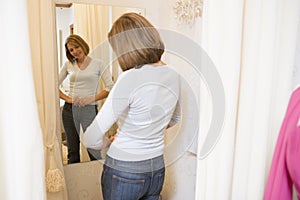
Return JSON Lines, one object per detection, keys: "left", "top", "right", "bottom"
{"left": 108, "top": 13, "right": 165, "bottom": 71}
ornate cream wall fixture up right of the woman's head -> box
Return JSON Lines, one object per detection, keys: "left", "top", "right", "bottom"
{"left": 174, "top": 0, "right": 203, "bottom": 25}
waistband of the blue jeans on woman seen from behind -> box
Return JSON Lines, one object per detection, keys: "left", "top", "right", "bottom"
{"left": 105, "top": 155, "right": 165, "bottom": 173}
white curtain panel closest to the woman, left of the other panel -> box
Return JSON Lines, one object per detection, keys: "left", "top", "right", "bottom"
{"left": 196, "top": 1, "right": 242, "bottom": 200}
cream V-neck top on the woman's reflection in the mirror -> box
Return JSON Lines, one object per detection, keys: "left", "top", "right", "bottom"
{"left": 59, "top": 59, "right": 113, "bottom": 104}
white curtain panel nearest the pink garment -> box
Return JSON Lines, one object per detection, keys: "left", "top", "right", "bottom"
{"left": 232, "top": 0, "right": 300, "bottom": 199}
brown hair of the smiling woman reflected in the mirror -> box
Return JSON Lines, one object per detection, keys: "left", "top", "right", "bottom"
{"left": 65, "top": 34, "right": 90, "bottom": 63}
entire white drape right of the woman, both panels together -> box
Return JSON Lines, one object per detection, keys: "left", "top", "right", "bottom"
{"left": 196, "top": 0, "right": 300, "bottom": 200}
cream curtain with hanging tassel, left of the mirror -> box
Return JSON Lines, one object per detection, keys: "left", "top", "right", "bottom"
{"left": 26, "top": 0, "right": 67, "bottom": 200}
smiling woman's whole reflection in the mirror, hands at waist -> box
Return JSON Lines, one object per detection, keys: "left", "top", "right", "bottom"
{"left": 59, "top": 35, "right": 113, "bottom": 163}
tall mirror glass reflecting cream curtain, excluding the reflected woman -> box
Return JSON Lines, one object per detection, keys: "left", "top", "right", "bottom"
{"left": 56, "top": 2, "right": 145, "bottom": 165}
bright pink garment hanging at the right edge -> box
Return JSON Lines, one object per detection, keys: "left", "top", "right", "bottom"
{"left": 264, "top": 87, "right": 300, "bottom": 200}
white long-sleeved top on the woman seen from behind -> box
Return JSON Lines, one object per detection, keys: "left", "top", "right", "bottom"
{"left": 82, "top": 65, "right": 181, "bottom": 161}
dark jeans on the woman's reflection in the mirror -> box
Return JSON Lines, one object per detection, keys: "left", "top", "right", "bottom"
{"left": 62, "top": 102, "right": 101, "bottom": 164}
